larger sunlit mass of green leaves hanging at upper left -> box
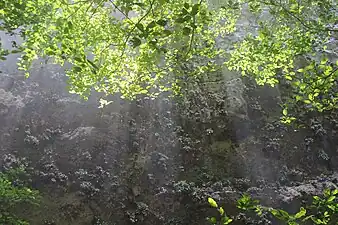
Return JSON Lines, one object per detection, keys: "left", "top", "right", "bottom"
{"left": 0, "top": 0, "right": 236, "bottom": 98}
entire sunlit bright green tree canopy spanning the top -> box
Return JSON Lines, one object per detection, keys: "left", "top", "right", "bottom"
{"left": 0, "top": 0, "right": 338, "bottom": 122}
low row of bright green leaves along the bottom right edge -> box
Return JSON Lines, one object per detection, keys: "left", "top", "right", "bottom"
{"left": 208, "top": 189, "right": 338, "bottom": 225}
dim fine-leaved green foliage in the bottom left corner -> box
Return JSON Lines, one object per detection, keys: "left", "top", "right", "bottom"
{"left": 0, "top": 168, "right": 39, "bottom": 225}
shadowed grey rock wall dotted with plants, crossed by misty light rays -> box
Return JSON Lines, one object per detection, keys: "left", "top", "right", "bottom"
{"left": 0, "top": 30, "right": 338, "bottom": 225}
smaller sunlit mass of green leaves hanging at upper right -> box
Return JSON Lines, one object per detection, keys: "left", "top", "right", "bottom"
{"left": 226, "top": 0, "right": 338, "bottom": 123}
